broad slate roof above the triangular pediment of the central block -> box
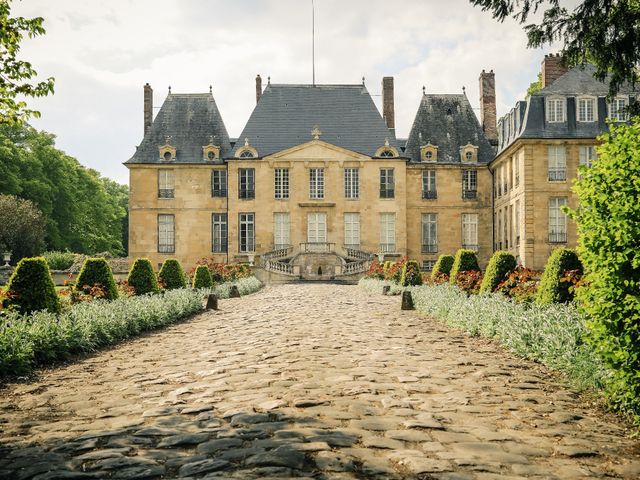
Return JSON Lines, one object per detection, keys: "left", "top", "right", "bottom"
{"left": 236, "top": 84, "right": 398, "bottom": 157}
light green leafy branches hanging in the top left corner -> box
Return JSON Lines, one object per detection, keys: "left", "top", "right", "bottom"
{"left": 0, "top": 0, "right": 54, "bottom": 124}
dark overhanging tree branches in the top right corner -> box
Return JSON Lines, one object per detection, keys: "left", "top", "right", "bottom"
{"left": 470, "top": 0, "right": 640, "bottom": 96}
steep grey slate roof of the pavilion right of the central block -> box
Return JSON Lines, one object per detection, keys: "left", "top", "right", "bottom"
{"left": 405, "top": 94, "right": 495, "bottom": 163}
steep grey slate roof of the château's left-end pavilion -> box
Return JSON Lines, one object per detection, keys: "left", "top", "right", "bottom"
{"left": 125, "top": 93, "right": 231, "bottom": 164}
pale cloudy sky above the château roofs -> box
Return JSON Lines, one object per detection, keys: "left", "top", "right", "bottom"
{"left": 12, "top": 0, "right": 555, "bottom": 184}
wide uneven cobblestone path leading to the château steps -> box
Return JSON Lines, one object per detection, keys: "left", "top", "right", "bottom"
{"left": 0, "top": 285, "right": 640, "bottom": 480}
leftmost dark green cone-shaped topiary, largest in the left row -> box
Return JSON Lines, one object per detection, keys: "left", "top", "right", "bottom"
{"left": 2, "top": 257, "right": 60, "bottom": 313}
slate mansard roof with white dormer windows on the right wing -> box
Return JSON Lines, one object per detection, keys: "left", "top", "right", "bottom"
{"left": 498, "top": 65, "right": 637, "bottom": 151}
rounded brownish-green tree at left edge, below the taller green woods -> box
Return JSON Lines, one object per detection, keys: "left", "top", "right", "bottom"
{"left": 0, "top": 195, "right": 44, "bottom": 261}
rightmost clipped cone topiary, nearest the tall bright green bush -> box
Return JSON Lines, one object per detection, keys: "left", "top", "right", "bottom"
{"left": 536, "top": 248, "right": 582, "bottom": 305}
